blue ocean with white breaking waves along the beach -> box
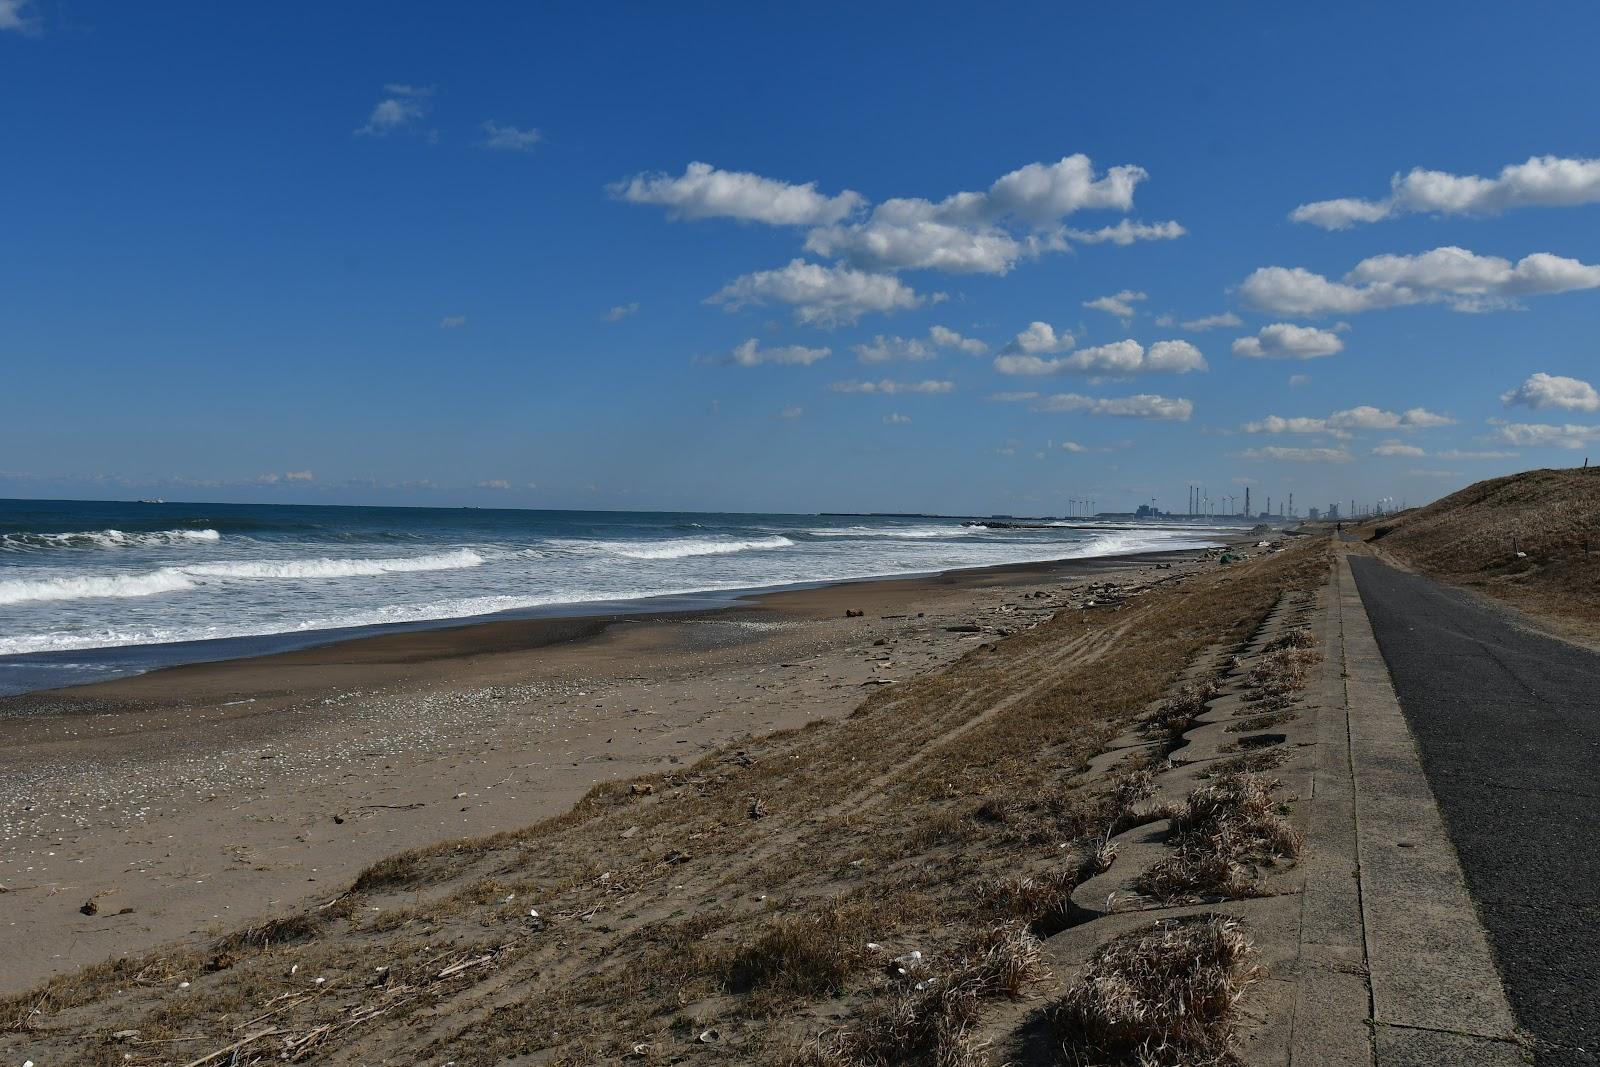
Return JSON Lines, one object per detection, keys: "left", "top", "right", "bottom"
{"left": 0, "top": 501, "right": 1216, "bottom": 694}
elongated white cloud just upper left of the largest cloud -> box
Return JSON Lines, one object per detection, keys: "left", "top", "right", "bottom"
{"left": 608, "top": 163, "right": 866, "bottom": 226}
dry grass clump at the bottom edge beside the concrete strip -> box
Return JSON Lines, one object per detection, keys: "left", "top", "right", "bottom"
{"left": 1051, "top": 915, "right": 1259, "bottom": 1067}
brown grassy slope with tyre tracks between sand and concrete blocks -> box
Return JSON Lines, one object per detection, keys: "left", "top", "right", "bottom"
{"left": 0, "top": 541, "right": 1328, "bottom": 1067}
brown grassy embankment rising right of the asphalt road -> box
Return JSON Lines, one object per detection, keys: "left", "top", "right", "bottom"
{"left": 1370, "top": 467, "right": 1600, "bottom": 635}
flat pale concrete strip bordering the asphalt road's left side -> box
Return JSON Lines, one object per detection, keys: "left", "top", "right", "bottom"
{"left": 1312, "top": 552, "right": 1526, "bottom": 1067}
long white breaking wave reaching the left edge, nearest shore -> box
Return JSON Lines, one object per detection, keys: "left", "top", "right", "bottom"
{"left": 0, "top": 549, "right": 483, "bottom": 605}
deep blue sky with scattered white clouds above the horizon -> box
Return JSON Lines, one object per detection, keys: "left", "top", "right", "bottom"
{"left": 0, "top": 0, "right": 1600, "bottom": 514}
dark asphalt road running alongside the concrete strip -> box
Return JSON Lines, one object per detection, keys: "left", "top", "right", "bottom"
{"left": 1350, "top": 555, "right": 1600, "bottom": 1065}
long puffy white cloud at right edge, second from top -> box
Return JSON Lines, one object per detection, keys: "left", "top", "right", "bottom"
{"left": 1240, "top": 246, "right": 1600, "bottom": 315}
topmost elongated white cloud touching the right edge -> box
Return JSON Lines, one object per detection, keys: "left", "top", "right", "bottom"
{"left": 1290, "top": 155, "right": 1600, "bottom": 230}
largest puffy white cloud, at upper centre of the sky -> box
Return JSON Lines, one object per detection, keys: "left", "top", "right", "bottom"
{"left": 806, "top": 154, "right": 1182, "bottom": 274}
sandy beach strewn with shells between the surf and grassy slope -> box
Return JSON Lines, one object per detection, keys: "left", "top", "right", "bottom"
{"left": 0, "top": 552, "right": 1200, "bottom": 992}
